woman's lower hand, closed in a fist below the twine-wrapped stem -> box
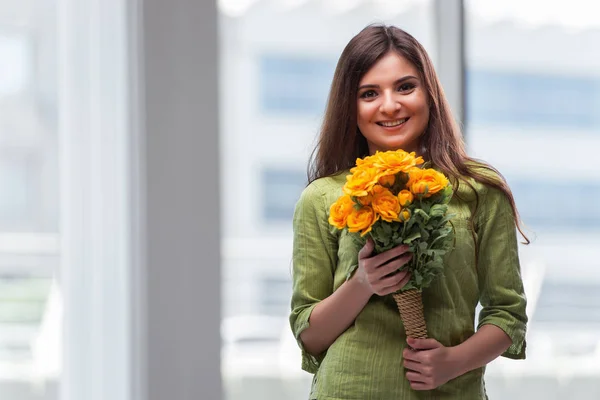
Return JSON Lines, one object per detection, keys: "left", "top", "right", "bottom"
{"left": 403, "top": 338, "right": 461, "bottom": 390}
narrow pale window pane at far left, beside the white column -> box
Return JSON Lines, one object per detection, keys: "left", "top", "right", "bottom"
{"left": 0, "top": 0, "right": 60, "bottom": 400}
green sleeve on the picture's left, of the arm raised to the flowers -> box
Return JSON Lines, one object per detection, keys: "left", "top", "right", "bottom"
{"left": 290, "top": 181, "right": 338, "bottom": 373}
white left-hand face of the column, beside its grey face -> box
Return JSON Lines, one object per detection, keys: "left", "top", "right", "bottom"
{"left": 58, "top": 0, "right": 131, "bottom": 400}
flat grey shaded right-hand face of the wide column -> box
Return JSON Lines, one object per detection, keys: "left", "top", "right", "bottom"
{"left": 132, "top": 0, "right": 222, "bottom": 400}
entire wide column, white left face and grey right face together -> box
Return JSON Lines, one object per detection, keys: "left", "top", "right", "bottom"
{"left": 58, "top": 0, "right": 222, "bottom": 400}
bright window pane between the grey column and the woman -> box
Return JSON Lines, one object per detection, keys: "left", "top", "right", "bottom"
{"left": 219, "top": 0, "right": 435, "bottom": 400}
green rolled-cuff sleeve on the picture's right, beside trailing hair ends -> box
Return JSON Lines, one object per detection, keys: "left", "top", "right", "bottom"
{"left": 476, "top": 188, "right": 527, "bottom": 359}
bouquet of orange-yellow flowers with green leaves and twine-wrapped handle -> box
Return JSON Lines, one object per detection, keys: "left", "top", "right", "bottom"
{"left": 329, "top": 150, "right": 452, "bottom": 338}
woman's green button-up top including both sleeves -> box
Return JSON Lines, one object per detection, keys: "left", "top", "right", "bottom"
{"left": 290, "top": 171, "right": 527, "bottom": 400}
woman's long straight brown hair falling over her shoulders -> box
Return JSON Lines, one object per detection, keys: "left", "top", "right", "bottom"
{"left": 308, "top": 25, "right": 529, "bottom": 243}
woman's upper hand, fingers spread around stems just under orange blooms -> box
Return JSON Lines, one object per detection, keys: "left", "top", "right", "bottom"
{"left": 355, "top": 238, "right": 412, "bottom": 296}
